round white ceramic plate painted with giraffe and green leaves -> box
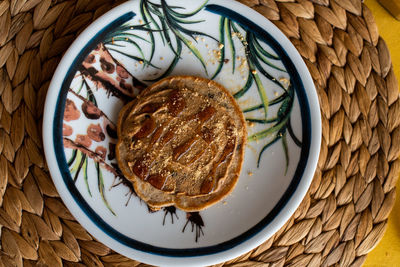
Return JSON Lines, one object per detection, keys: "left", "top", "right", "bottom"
{"left": 43, "top": 0, "right": 321, "bottom": 266}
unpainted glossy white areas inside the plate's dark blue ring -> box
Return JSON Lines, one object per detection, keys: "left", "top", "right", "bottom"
{"left": 65, "top": 1, "right": 302, "bottom": 248}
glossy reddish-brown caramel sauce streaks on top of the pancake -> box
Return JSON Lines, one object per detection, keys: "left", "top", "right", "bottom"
{"left": 131, "top": 90, "right": 236, "bottom": 194}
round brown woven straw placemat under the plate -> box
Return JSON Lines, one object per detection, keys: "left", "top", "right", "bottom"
{"left": 0, "top": 0, "right": 400, "bottom": 267}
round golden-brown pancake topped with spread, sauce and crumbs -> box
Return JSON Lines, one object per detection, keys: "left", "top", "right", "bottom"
{"left": 116, "top": 76, "right": 247, "bottom": 211}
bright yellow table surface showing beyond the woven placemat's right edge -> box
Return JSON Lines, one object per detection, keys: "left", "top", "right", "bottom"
{"left": 363, "top": 0, "right": 400, "bottom": 267}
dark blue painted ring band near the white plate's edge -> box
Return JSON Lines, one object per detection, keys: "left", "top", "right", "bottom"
{"left": 52, "top": 4, "right": 312, "bottom": 257}
